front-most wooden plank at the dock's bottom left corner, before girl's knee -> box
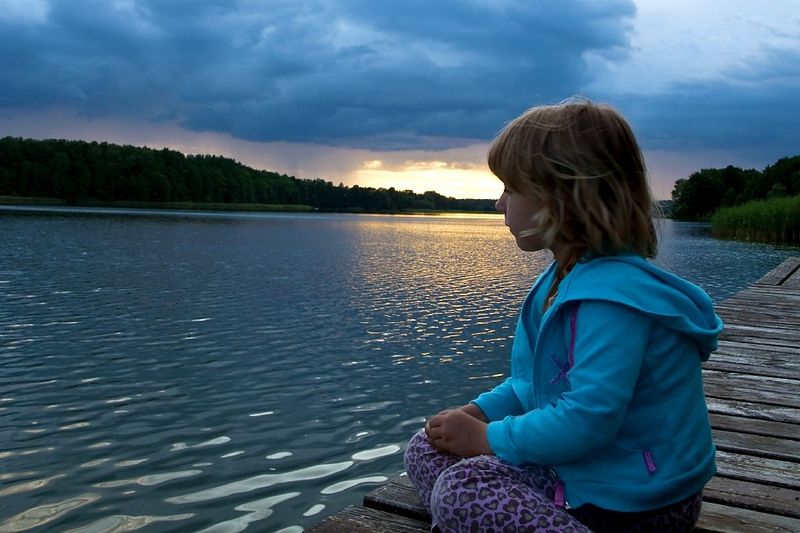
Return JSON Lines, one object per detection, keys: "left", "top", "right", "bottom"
{"left": 306, "top": 505, "right": 431, "bottom": 533}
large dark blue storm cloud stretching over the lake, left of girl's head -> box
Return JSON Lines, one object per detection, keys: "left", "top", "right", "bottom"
{"left": 0, "top": 0, "right": 635, "bottom": 149}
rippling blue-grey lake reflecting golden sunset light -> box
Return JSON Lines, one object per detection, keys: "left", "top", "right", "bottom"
{"left": 0, "top": 207, "right": 800, "bottom": 533}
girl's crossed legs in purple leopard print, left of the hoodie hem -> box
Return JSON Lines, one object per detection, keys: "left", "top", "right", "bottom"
{"left": 405, "top": 432, "right": 589, "bottom": 533}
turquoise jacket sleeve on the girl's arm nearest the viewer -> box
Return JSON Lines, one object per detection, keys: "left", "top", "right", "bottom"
{"left": 488, "top": 301, "right": 651, "bottom": 466}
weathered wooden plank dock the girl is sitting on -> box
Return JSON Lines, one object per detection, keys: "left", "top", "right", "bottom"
{"left": 309, "top": 257, "right": 800, "bottom": 533}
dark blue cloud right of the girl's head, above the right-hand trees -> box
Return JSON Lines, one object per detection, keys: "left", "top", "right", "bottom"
{"left": 620, "top": 48, "right": 800, "bottom": 159}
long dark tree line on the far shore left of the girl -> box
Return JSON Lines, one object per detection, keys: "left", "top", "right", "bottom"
{"left": 0, "top": 137, "right": 494, "bottom": 212}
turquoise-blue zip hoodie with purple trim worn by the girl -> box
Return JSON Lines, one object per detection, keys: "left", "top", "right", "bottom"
{"left": 474, "top": 255, "right": 722, "bottom": 512}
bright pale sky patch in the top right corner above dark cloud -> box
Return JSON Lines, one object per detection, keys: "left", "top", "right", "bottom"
{"left": 590, "top": 0, "right": 800, "bottom": 94}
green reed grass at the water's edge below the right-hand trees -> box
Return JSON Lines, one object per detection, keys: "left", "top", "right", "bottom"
{"left": 711, "top": 195, "right": 800, "bottom": 244}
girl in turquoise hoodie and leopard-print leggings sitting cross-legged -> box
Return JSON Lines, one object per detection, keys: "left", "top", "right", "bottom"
{"left": 405, "top": 101, "right": 722, "bottom": 532}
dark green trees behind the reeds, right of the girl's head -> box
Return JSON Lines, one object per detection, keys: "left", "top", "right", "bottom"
{"left": 672, "top": 156, "right": 800, "bottom": 220}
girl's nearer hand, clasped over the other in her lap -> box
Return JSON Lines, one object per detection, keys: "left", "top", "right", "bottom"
{"left": 425, "top": 409, "right": 492, "bottom": 457}
